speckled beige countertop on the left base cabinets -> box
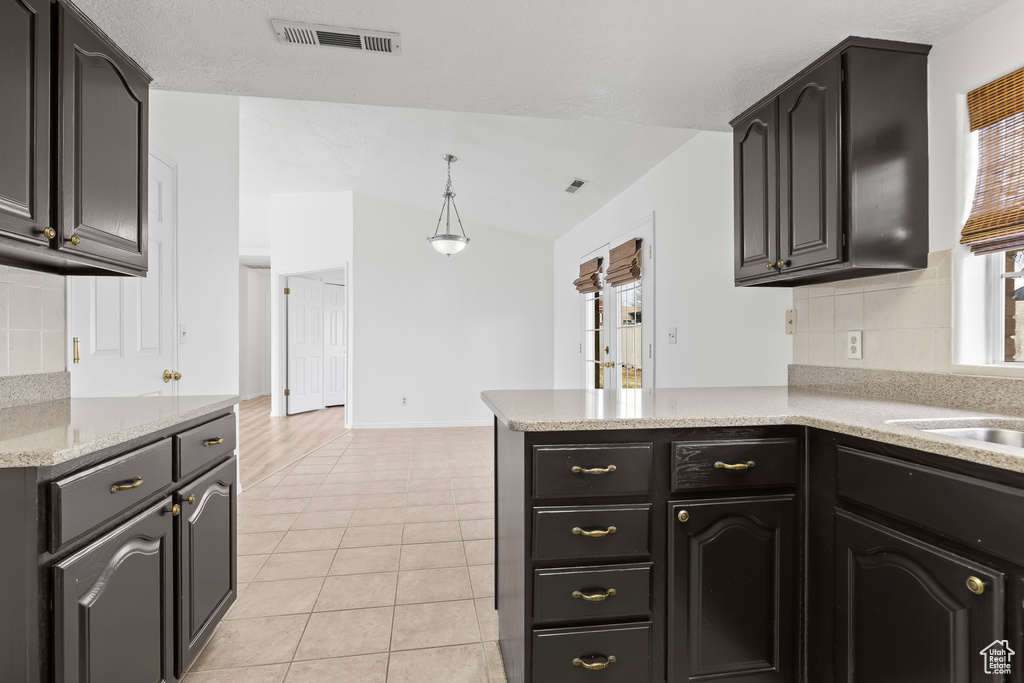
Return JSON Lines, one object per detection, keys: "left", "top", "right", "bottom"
{"left": 0, "top": 395, "right": 239, "bottom": 468}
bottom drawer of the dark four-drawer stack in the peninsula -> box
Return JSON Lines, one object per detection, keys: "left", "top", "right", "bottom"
{"left": 534, "top": 622, "right": 650, "bottom": 683}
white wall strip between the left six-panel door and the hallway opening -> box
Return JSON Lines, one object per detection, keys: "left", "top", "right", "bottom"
{"left": 150, "top": 90, "right": 239, "bottom": 394}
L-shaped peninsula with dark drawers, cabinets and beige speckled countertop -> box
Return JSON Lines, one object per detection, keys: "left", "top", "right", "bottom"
{"left": 482, "top": 386, "right": 1024, "bottom": 683}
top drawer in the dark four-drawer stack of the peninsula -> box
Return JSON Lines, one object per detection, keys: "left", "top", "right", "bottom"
{"left": 534, "top": 443, "right": 651, "bottom": 498}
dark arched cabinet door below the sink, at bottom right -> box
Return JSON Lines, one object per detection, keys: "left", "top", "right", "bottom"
{"left": 836, "top": 512, "right": 1016, "bottom": 683}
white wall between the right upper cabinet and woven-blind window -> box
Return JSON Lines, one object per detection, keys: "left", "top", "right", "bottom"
{"left": 928, "top": 0, "right": 1024, "bottom": 252}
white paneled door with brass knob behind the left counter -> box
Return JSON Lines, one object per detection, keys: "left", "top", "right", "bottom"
{"left": 68, "top": 155, "right": 178, "bottom": 396}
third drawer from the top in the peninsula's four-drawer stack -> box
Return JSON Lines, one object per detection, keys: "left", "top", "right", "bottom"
{"left": 534, "top": 563, "right": 651, "bottom": 622}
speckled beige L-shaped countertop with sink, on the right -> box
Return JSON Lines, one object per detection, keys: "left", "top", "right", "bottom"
{"left": 481, "top": 387, "right": 1024, "bottom": 472}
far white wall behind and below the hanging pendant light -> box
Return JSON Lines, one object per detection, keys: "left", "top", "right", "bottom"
{"left": 354, "top": 195, "right": 553, "bottom": 427}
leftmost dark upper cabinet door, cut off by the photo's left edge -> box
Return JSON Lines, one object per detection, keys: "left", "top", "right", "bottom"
{"left": 0, "top": 0, "right": 50, "bottom": 244}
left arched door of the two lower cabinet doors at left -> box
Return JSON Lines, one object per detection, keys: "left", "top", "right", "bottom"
{"left": 53, "top": 499, "right": 174, "bottom": 683}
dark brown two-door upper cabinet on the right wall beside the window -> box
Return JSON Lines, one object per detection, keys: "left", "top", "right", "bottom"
{"left": 732, "top": 38, "right": 930, "bottom": 287}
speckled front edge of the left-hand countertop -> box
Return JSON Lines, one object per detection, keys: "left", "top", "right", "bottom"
{"left": 0, "top": 396, "right": 240, "bottom": 469}
